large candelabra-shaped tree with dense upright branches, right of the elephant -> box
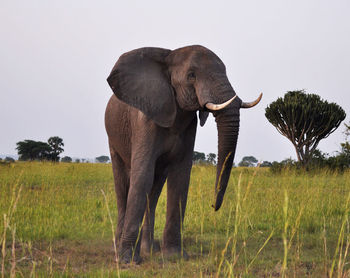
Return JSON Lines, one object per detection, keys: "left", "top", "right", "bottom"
{"left": 265, "top": 90, "right": 346, "bottom": 167}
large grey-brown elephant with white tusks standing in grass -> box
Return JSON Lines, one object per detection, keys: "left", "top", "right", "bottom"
{"left": 105, "top": 45, "right": 262, "bottom": 264}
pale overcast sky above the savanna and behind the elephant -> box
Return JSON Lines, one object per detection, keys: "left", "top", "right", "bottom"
{"left": 0, "top": 0, "right": 350, "bottom": 163}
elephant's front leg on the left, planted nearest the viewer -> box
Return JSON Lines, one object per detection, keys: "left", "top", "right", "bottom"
{"left": 118, "top": 161, "right": 154, "bottom": 264}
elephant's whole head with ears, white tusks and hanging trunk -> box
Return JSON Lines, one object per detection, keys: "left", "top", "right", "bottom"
{"left": 107, "top": 46, "right": 262, "bottom": 210}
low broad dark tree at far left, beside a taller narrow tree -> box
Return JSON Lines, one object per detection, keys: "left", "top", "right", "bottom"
{"left": 16, "top": 140, "right": 52, "bottom": 160}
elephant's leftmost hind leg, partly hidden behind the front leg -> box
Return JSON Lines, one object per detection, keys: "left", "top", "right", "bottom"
{"left": 110, "top": 148, "right": 130, "bottom": 248}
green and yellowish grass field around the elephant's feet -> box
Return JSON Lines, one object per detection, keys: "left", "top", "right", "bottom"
{"left": 0, "top": 162, "right": 350, "bottom": 278}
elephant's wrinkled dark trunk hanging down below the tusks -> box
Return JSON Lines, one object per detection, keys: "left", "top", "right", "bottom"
{"left": 214, "top": 109, "right": 239, "bottom": 211}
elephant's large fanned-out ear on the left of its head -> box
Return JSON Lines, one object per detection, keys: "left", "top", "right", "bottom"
{"left": 107, "top": 47, "right": 176, "bottom": 127}
